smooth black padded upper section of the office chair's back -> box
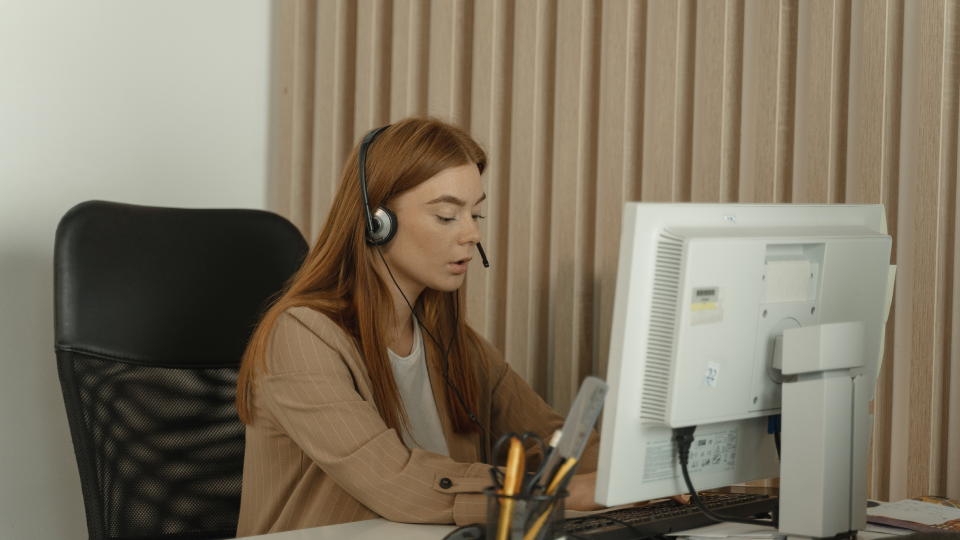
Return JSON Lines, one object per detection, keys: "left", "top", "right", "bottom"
{"left": 54, "top": 201, "right": 307, "bottom": 368}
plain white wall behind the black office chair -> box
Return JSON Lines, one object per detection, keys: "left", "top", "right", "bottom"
{"left": 0, "top": 0, "right": 270, "bottom": 540}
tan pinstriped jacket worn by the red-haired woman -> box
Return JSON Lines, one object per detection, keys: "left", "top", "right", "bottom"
{"left": 237, "top": 307, "right": 599, "bottom": 536}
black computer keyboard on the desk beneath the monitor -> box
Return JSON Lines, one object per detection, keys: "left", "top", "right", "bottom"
{"left": 562, "top": 493, "right": 777, "bottom": 540}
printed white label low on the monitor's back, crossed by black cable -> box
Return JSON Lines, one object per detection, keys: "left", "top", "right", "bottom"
{"left": 643, "top": 429, "right": 740, "bottom": 483}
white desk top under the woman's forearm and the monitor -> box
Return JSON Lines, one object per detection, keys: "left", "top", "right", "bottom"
{"left": 238, "top": 519, "right": 896, "bottom": 540}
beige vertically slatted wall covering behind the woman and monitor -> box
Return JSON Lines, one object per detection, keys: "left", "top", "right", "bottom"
{"left": 271, "top": 0, "right": 960, "bottom": 500}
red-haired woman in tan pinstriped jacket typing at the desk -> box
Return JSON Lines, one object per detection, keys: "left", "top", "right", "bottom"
{"left": 237, "top": 118, "right": 598, "bottom": 536}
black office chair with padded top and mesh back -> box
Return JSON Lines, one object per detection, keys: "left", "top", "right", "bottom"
{"left": 54, "top": 201, "right": 307, "bottom": 540}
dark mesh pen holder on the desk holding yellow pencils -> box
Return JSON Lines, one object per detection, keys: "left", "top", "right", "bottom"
{"left": 483, "top": 487, "right": 570, "bottom": 540}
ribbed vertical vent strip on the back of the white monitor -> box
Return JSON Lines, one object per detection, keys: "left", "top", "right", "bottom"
{"left": 640, "top": 232, "right": 683, "bottom": 424}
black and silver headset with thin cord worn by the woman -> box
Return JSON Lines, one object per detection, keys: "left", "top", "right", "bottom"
{"left": 358, "top": 125, "right": 490, "bottom": 463}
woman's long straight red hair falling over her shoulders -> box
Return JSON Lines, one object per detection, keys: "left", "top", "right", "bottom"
{"left": 237, "top": 118, "right": 487, "bottom": 433}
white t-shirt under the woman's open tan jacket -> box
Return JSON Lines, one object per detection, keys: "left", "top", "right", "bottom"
{"left": 387, "top": 319, "right": 450, "bottom": 457}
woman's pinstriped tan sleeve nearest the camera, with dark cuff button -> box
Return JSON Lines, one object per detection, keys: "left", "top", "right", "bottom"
{"left": 257, "top": 313, "right": 490, "bottom": 523}
